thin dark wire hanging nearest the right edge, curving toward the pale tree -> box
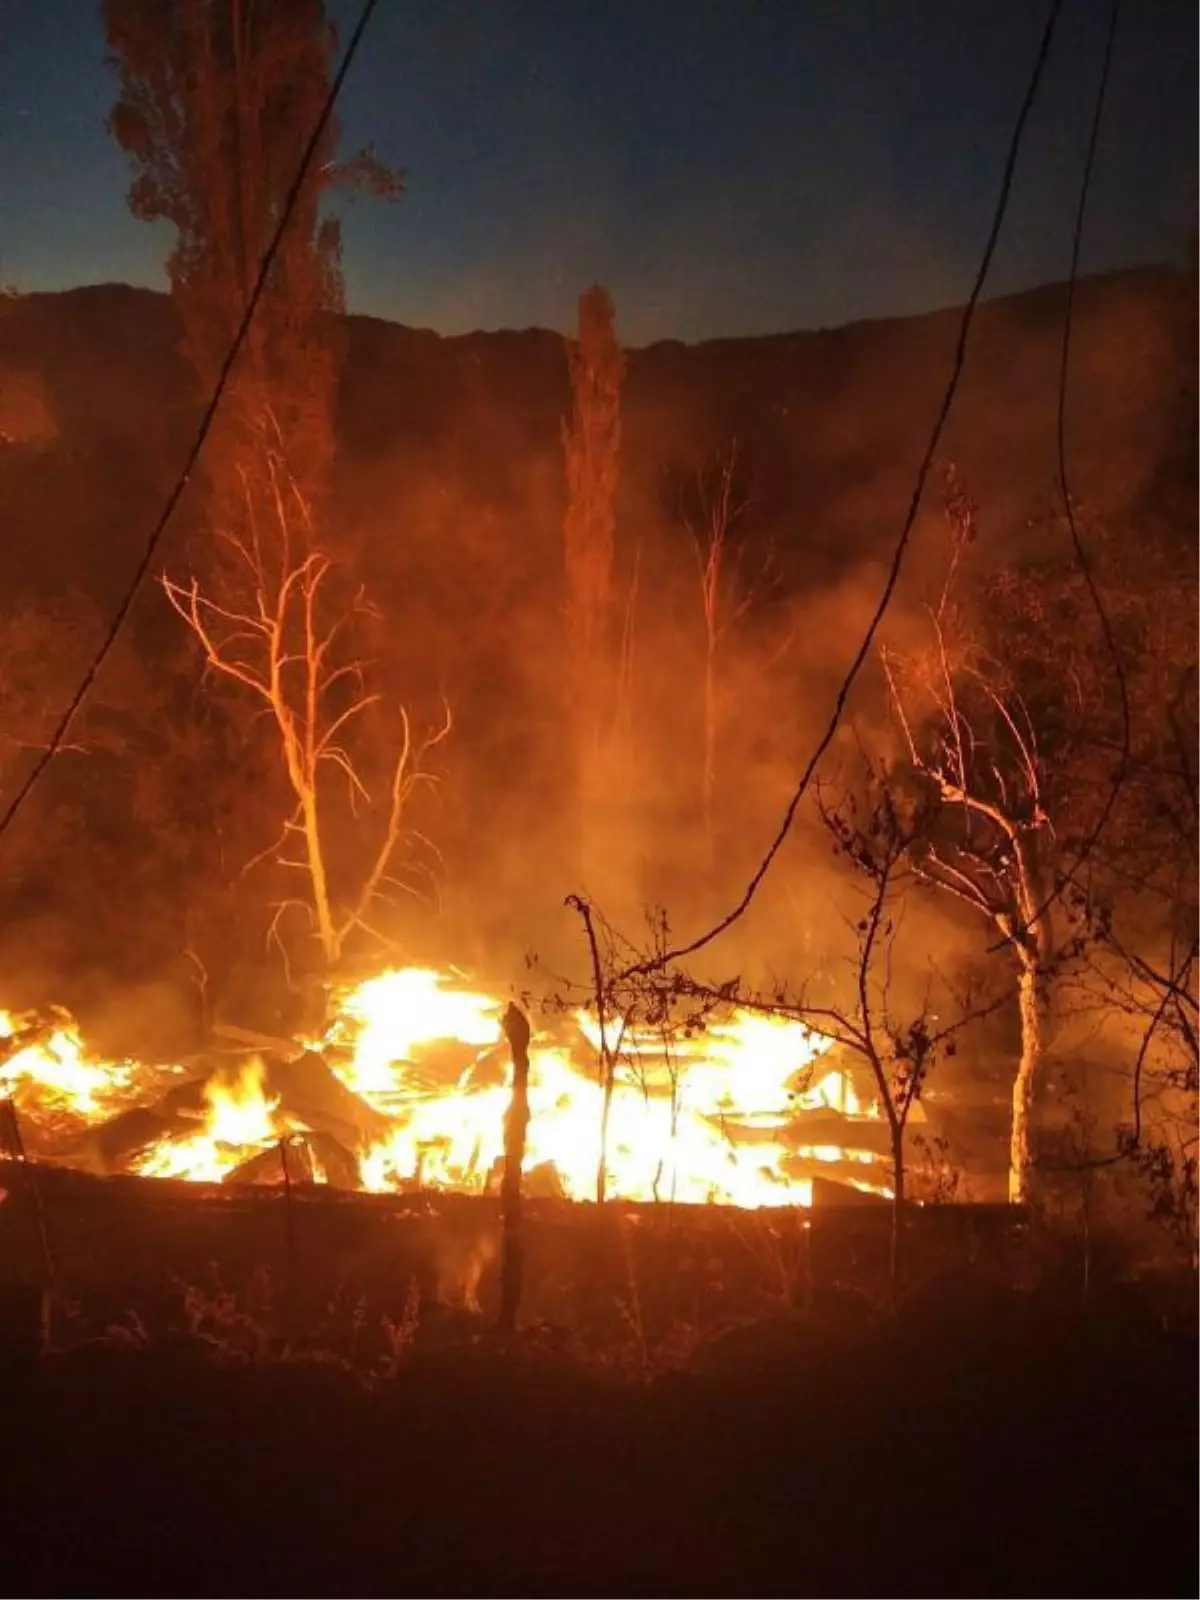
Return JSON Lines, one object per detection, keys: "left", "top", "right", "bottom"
{"left": 989, "top": 0, "right": 1133, "bottom": 954}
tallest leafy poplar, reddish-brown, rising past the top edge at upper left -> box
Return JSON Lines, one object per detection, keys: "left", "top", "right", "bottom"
{"left": 104, "top": 0, "right": 400, "bottom": 544}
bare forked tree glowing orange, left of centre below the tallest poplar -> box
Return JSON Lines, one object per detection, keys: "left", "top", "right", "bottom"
{"left": 165, "top": 448, "right": 450, "bottom": 970}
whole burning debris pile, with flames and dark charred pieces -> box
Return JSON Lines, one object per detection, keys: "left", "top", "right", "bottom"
{"left": 0, "top": 968, "right": 890, "bottom": 1208}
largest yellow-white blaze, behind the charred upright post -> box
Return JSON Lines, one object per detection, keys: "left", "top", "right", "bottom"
{"left": 331, "top": 970, "right": 885, "bottom": 1206}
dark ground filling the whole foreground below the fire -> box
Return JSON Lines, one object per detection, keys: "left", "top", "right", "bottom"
{"left": 0, "top": 1173, "right": 1200, "bottom": 1600}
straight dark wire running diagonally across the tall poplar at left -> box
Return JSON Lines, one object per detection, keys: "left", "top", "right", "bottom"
{"left": 0, "top": 0, "right": 378, "bottom": 838}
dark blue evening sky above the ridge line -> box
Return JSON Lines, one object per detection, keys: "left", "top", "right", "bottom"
{"left": 0, "top": 0, "right": 1200, "bottom": 342}
